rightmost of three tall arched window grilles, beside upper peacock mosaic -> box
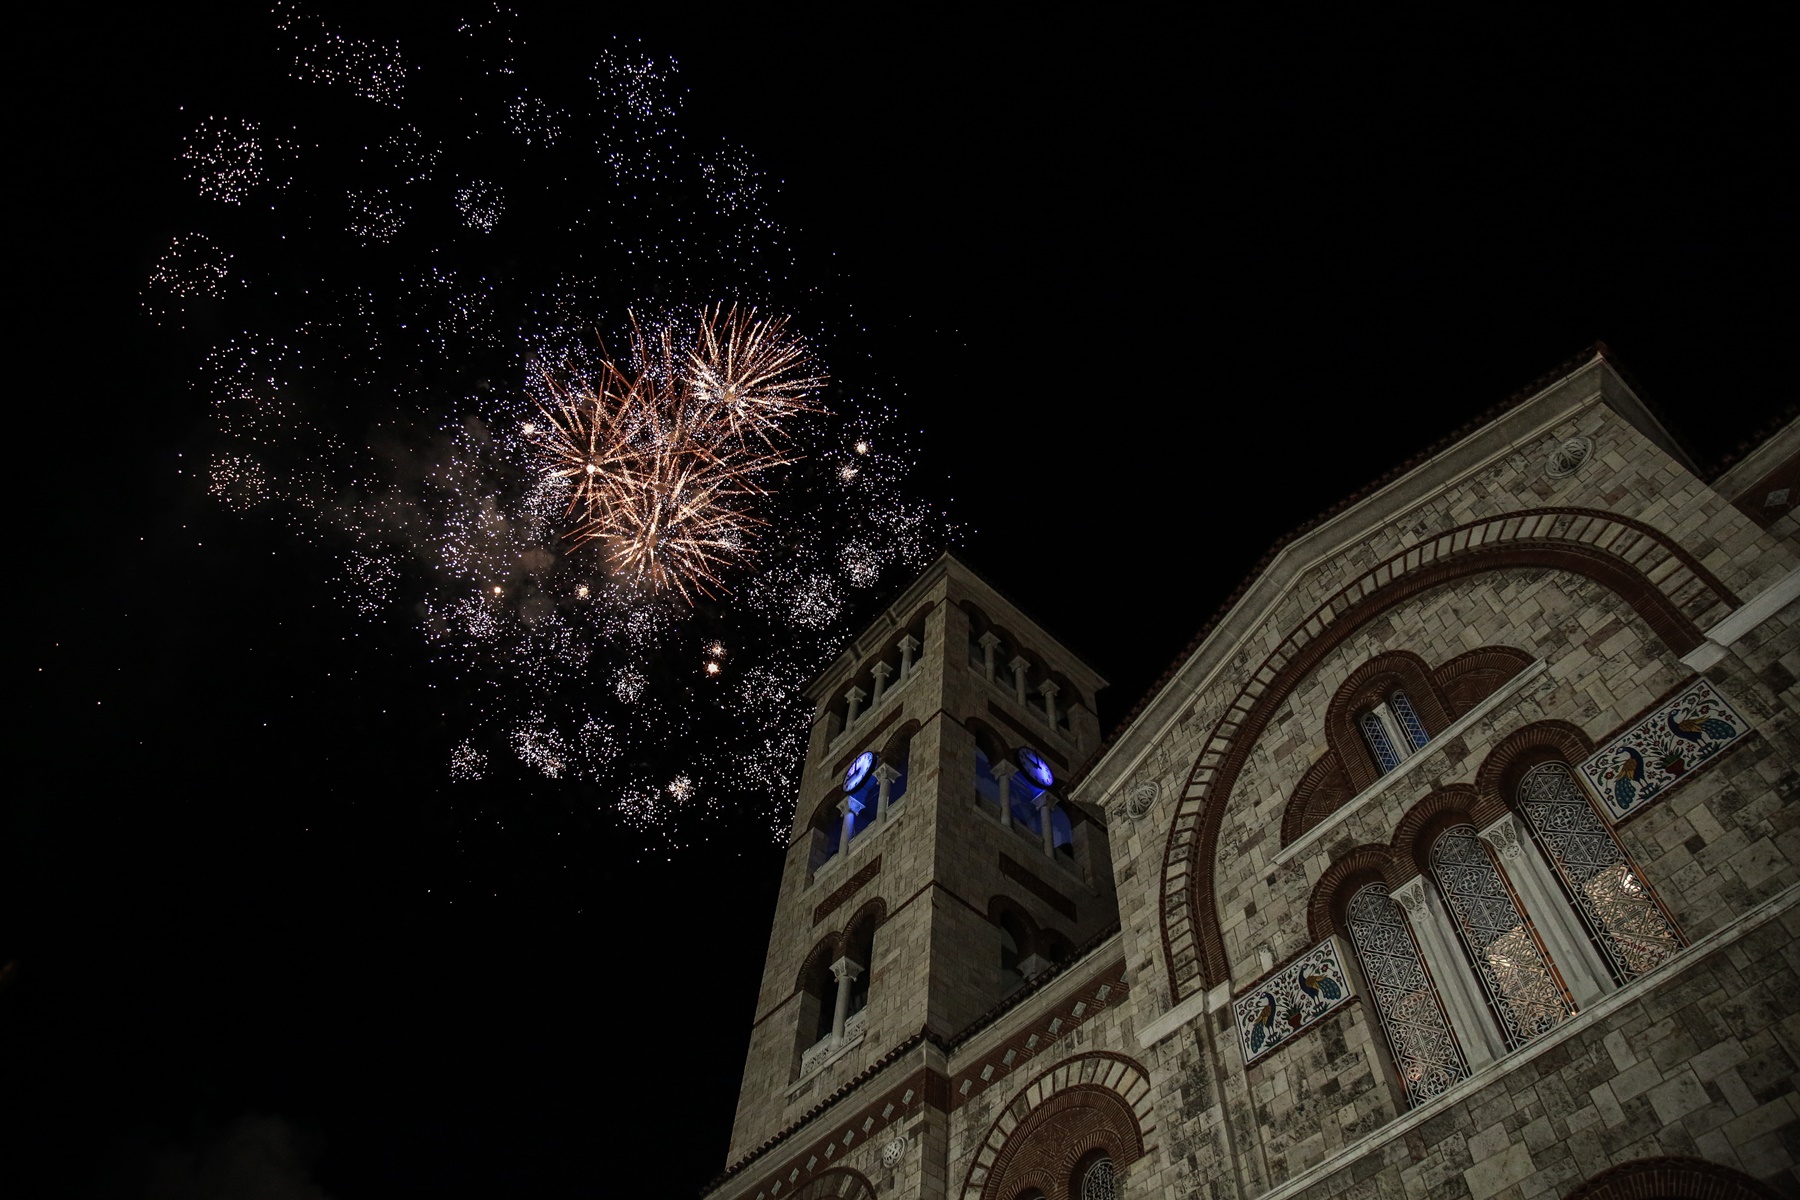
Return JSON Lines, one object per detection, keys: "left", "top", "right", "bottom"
{"left": 1517, "top": 763, "right": 1681, "bottom": 984}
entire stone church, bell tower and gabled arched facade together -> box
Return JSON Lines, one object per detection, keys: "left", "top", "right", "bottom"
{"left": 707, "top": 351, "right": 1800, "bottom": 1200}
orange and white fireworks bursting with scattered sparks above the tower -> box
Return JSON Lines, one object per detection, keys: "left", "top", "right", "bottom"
{"left": 154, "top": 4, "right": 954, "bottom": 849}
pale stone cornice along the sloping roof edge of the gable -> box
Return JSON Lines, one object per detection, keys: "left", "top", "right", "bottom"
{"left": 1069, "top": 342, "right": 1670, "bottom": 806}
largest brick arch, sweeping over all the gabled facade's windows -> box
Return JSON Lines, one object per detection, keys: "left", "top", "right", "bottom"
{"left": 1157, "top": 507, "right": 1739, "bottom": 1002}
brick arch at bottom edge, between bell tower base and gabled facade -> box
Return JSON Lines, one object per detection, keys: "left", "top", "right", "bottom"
{"left": 961, "top": 1051, "right": 1154, "bottom": 1200}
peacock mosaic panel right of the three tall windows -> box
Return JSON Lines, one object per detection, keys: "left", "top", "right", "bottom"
{"left": 1580, "top": 680, "right": 1750, "bottom": 822}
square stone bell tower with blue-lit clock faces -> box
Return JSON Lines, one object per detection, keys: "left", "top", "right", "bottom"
{"left": 712, "top": 554, "right": 1118, "bottom": 1196}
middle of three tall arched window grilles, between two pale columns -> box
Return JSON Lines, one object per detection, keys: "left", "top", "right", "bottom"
{"left": 1431, "top": 824, "right": 1575, "bottom": 1051}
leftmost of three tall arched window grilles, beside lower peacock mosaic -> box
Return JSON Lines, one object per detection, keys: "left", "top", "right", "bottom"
{"left": 1345, "top": 883, "right": 1469, "bottom": 1106}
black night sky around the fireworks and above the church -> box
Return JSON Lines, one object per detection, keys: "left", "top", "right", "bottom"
{"left": 14, "top": 5, "right": 1795, "bottom": 1200}
